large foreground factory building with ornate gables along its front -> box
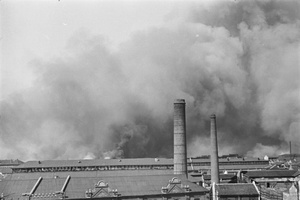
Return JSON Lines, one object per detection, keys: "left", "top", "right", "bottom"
{"left": 0, "top": 171, "right": 207, "bottom": 200}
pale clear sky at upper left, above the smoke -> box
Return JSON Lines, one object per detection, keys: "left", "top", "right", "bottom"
{"left": 0, "top": 0, "right": 179, "bottom": 99}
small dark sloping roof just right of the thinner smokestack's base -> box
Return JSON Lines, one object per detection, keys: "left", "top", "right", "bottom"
{"left": 216, "top": 183, "right": 259, "bottom": 196}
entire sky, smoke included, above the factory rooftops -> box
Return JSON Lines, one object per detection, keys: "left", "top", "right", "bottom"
{"left": 0, "top": 0, "right": 300, "bottom": 160}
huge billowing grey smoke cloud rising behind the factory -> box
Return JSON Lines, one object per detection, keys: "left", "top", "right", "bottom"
{"left": 0, "top": 0, "right": 300, "bottom": 160}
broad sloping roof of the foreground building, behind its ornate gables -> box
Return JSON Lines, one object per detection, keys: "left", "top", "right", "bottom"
{"left": 0, "top": 174, "right": 207, "bottom": 198}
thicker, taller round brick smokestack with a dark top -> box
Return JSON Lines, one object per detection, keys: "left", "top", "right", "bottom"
{"left": 174, "top": 99, "right": 187, "bottom": 176}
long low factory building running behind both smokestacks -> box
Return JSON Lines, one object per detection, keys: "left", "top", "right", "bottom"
{"left": 7, "top": 157, "right": 269, "bottom": 176}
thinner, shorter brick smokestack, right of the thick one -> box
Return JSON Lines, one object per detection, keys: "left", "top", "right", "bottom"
{"left": 210, "top": 114, "right": 220, "bottom": 184}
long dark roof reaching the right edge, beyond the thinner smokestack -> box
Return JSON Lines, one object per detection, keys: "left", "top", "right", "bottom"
{"left": 244, "top": 170, "right": 297, "bottom": 178}
